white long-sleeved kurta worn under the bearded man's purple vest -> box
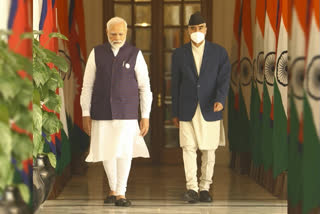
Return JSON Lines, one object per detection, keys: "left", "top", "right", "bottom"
{"left": 80, "top": 46, "right": 152, "bottom": 162}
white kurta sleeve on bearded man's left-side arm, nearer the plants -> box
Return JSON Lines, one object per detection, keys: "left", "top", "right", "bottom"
{"left": 80, "top": 49, "right": 96, "bottom": 117}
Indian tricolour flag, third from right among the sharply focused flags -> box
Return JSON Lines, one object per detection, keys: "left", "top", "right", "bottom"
{"left": 250, "top": 0, "right": 266, "bottom": 167}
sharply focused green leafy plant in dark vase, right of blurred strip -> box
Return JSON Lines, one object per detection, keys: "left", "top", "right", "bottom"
{"left": 32, "top": 31, "right": 69, "bottom": 168}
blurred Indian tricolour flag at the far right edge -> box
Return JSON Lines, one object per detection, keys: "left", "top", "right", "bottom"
{"left": 302, "top": 0, "right": 320, "bottom": 213}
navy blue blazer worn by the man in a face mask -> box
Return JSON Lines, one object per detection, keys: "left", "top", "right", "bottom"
{"left": 171, "top": 40, "right": 231, "bottom": 121}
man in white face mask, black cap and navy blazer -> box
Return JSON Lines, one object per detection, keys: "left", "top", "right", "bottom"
{"left": 171, "top": 12, "right": 231, "bottom": 203}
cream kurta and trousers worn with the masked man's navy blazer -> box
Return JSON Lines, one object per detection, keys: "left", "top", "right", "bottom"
{"left": 179, "top": 42, "right": 225, "bottom": 192}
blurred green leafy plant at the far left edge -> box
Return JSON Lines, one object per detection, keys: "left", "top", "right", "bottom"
{"left": 0, "top": 31, "right": 33, "bottom": 202}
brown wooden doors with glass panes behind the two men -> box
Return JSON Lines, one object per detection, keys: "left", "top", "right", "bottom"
{"left": 103, "top": 0, "right": 212, "bottom": 164}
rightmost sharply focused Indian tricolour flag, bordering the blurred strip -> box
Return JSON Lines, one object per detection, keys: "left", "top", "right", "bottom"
{"left": 272, "top": 0, "right": 288, "bottom": 177}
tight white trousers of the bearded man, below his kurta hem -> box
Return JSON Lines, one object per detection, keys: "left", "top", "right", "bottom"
{"left": 102, "top": 158, "right": 132, "bottom": 195}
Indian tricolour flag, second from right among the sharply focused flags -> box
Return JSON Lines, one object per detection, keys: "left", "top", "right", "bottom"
{"left": 262, "top": 0, "right": 279, "bottom": 170}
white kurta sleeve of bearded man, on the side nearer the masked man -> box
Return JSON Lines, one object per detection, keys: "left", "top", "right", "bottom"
{"left": 134, "top": 51, "right": 152, "bottom": 118}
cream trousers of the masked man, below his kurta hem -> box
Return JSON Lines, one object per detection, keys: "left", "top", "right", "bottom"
{"left": 182, "top": 146, "right": 215, "bottom": 192}
